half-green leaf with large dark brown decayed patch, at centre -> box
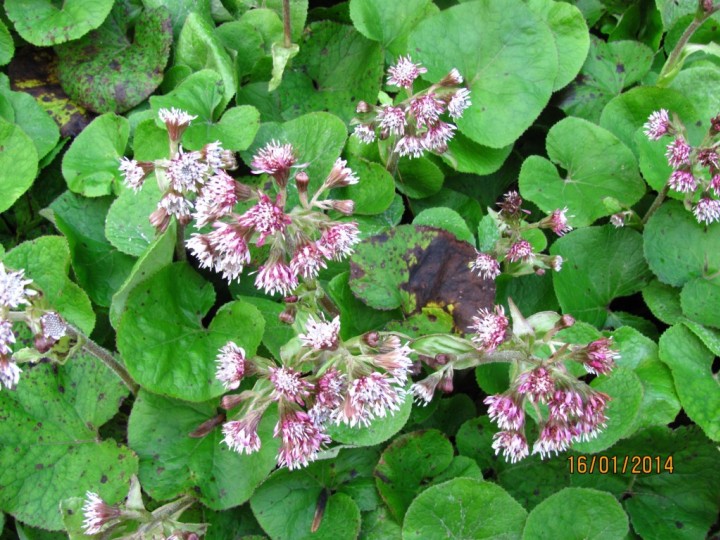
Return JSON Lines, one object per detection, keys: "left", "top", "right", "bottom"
{"left": 350, "top": 225, "right": 495, "bottom": 332}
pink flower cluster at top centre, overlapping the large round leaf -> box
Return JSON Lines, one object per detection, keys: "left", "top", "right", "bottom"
{"left": 355, "top": 56, "right": 471, "bottom": 158}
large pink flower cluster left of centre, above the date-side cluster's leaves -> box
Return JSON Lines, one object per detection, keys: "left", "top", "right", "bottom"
{"left": 187, "top": 141, "right": 360, "bottom": 295}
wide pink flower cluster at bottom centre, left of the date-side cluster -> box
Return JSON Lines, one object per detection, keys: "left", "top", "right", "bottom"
{"left": 217, "top": 318, "right": 412, "bottom": 469}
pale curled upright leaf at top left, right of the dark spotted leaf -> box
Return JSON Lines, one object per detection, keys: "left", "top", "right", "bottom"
{"left": 175, "top": 12, "right": 237, "bottom": 110}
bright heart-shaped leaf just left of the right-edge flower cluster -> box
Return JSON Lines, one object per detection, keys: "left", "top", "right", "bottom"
{"left": 519, "top": 118, "right": 645, "bottom": 227}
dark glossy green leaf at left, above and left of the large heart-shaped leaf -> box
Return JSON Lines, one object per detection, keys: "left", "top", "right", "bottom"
{"left": 50, "top": 191, "right": 134, "bottom": 307}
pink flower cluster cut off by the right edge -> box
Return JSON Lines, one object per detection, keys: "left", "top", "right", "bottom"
{"left": 644, "top": 109, "right": 720, "bottom": 225}
